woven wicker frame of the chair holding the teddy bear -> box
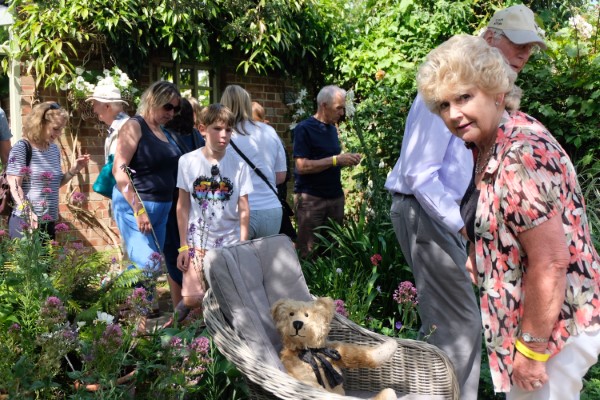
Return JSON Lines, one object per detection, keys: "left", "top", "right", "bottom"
{"left": 203, "top": 239, "right": 459, "bottom": 400}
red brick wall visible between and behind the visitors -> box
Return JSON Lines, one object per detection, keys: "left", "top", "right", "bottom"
{"left": 15, "top": 62, "right": 300, "bottom": 252}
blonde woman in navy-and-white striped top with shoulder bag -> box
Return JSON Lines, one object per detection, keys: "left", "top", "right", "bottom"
{"left": 6, "top": 102, "right": 90, "bottom": 239}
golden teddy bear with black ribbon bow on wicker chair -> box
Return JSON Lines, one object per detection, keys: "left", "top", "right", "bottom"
{"left": 271, "top": 297, "right": 398, "bottom": 400}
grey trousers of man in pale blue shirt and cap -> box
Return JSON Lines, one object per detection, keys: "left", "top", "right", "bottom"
{"left": 390, "top": 195, "right": 481, "bottom": 400}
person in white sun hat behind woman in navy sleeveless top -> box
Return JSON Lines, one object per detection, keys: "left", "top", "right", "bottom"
{"left": 86, "top": 81, "right": 129, "bottom": 163}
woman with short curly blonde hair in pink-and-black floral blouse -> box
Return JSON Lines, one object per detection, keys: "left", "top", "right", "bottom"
{"left": 417, "top": 35, "right": 600, "bottom": 399}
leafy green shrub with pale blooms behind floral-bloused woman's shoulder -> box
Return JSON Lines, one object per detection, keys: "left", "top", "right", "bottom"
{"left": 519, "top": 4, "right": 600, "bottom": 163}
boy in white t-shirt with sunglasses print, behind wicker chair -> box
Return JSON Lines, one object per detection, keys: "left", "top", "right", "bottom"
{"left": 177, "top": 104, "right": 253, "bottom": 307}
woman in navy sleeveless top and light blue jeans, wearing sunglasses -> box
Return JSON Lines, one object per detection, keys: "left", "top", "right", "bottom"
{"left": 112, "top": 81, "right": 181, "bottom": 270}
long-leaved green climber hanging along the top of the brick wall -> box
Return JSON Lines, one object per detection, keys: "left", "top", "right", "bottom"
{"left": 4, "top": 0, "right": 343, "bottom": 87}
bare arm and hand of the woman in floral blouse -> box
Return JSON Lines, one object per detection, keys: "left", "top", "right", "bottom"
{"left": 513, "top": 215, "right": 570, "bottom": 390}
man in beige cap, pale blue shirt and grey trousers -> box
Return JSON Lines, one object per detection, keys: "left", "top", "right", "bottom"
{"left": 385, "top": 5, "right": 546, "bottom": 400}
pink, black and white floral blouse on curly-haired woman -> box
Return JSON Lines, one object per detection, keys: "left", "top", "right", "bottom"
{"left": 475, "top": 112, "right": 600, "bottom": 392}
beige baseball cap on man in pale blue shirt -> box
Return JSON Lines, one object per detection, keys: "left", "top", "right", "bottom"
{"left": 488, "top": 4, "right": 546, "bottom": 49}
